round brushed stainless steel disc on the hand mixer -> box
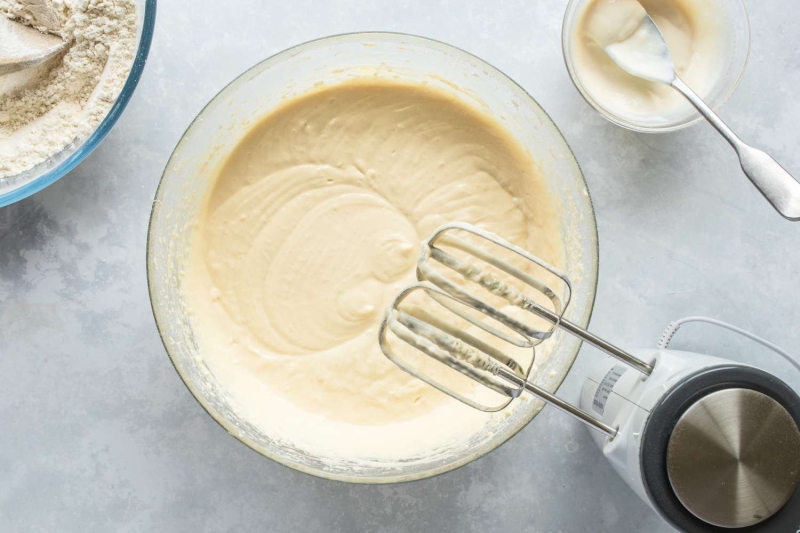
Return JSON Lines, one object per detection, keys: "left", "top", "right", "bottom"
{"left": 667, "top": 388, "right": 800, "bottom": 528}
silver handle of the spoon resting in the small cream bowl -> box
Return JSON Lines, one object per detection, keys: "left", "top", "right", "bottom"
{"left": 672, "top": 76, "right": 800, "bottom": 221}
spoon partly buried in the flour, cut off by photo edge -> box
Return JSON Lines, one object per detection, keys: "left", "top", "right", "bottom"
{"left": 0, "top": 16, "right": 67, "bottom": 76}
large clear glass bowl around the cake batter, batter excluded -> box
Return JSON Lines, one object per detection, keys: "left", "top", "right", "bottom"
{"left": 147, "top": 33, "right": 598, "bottom": 483}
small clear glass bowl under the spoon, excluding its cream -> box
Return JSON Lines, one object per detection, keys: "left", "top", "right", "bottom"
{"left": 561, "top": 0, "right": 750, "bottom": 133}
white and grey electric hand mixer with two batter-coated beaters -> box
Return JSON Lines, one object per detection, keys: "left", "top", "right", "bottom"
{"left": 380, "top": 224, "right": 800, "bottom": 533}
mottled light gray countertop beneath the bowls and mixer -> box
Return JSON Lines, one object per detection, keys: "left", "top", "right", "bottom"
{"left": 0, "top": 0, "right": 800, "bottom": 533}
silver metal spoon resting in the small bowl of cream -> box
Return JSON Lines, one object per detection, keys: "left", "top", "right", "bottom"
{"left": 605, "top": 13, "right": 800, "bottom": 221}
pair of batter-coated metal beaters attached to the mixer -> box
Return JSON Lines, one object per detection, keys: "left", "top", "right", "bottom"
{"left": 379, "top": 223, "right": 653, "bottom": 438}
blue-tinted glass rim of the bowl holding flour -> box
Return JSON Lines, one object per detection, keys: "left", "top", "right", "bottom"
{"left": 0, "top": 0, "right": 156, "bottom": 207}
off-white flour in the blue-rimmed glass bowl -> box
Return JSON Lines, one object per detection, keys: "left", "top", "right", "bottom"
{"left": 0, "top": 0, "right": 137, "bottom": 179}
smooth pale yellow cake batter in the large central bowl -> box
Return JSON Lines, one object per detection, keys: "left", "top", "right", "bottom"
{"left": 182, "top": 80, "right": 563, "bottom": 458}
